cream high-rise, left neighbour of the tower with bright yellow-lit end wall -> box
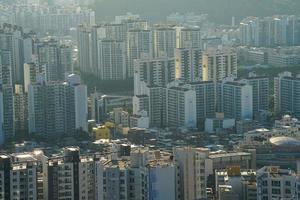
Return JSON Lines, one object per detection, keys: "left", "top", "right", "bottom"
{"left": 174, "top": 48, "right": 202, "bottom": 83}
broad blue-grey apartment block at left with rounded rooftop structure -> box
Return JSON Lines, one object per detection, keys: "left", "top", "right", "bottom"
{"left": 28, "top": 74, "right": 87, "bottom": 138}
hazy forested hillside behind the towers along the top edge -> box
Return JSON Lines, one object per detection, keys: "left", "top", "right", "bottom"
{"left": 93, "top": 0, "right": 300, "bottom": 23}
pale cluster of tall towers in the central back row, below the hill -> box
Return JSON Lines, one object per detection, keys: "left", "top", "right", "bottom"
{"left": 77, "top": 14, "right": 201, "bottom": 80}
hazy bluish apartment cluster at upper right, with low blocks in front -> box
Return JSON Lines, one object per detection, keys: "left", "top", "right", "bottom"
{"left": 235, "top": 15, "right": 300, "bottom": 67}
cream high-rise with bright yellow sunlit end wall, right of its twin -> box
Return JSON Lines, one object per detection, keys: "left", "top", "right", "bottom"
{"left": 202, "top": 48, "right": 237, "bottom": 82}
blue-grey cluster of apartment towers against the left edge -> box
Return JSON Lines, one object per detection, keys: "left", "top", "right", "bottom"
{"left": 0, "top": 24, "right": 87, "bottom": 143}
